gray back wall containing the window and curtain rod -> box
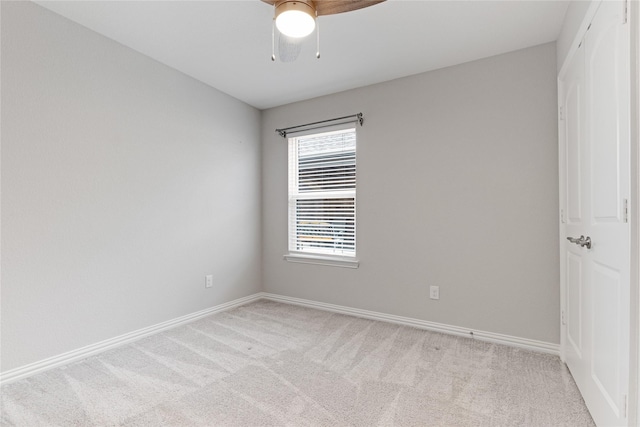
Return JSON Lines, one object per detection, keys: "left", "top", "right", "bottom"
{"left": 262, "top": 43, "right": 560, "bottom": 343}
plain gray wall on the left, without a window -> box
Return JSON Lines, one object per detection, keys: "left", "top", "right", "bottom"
{"left": 1, "top": 2, "right": 261, "bottom": 371}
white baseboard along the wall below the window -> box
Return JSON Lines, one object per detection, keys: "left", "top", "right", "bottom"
{"left": 261, "top": 292, "right": 560, "bottom": 356}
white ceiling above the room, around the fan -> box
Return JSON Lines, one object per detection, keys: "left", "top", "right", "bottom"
{"left": 37, "top": 0, "right": 568, "bottom": 109}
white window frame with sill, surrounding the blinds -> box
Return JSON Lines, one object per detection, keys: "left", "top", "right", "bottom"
{"left": 284, "top": 124, "right": 360, "bottom": 268}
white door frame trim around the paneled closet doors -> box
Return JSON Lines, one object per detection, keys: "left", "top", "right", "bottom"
{"left": 557, "top": 0, "right": 640, "bottom": 426}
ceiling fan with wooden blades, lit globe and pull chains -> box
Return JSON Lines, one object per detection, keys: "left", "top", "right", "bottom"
{"left": 261, "top": 0, "right": 385, "bottom": 62}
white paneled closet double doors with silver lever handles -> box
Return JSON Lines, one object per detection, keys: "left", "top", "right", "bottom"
{"left": 560, "top": 1, "right": 630, "bottom": 426}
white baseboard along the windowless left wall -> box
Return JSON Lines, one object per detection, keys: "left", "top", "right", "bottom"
{"left": 0, "top": 292, "right": 262, "bottom": 385}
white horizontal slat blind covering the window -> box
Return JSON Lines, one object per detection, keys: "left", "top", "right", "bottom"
{"left": 289, "top": 129, "right": 356, "bottom": 257}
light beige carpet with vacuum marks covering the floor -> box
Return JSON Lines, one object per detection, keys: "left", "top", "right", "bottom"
{"left": 1, "top": 301, "right": 593, "bottom": 427}
